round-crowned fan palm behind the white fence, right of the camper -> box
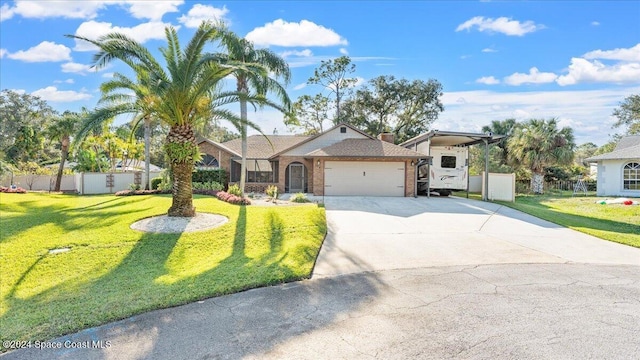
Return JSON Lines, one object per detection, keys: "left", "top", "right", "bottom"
{"left": 507, "top": 119, "right": 575, "bottom": 194}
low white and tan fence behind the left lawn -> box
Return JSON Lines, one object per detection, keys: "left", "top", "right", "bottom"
{"left": 0, "top": 171, "right": 160, "bottom": 195}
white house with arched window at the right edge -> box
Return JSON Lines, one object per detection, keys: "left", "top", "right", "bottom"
{"left": 585, "top": 135, "right": 640, "bottom": 197}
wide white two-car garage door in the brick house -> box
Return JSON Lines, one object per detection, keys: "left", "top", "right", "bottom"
{"left": 324, "top": 161, "right": 404, "bottom": 196}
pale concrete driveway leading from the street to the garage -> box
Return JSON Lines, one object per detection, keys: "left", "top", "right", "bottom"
{"left": 314, "top": 197, "right": 640, "bottom": 276}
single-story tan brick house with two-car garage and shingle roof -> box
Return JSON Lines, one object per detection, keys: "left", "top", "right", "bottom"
{"left": 198, "top": 124, "right": 428, "bottom": 196}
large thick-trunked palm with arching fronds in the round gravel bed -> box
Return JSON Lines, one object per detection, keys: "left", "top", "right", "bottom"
{"left": 68, "top": 22, "right": 255, "bottom": 217}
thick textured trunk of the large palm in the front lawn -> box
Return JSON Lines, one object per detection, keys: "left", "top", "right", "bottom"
{"left": 167, "top": 125, "right": 197, "bottom": 217}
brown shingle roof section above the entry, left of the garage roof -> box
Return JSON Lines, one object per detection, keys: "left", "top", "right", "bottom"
{"left": 222, "top": 135, "right": 309, "bottom": 159}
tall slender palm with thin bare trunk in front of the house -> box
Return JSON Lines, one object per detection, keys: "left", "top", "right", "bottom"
{"left": 212, "top": 25, "right": 291, "bottom": 195}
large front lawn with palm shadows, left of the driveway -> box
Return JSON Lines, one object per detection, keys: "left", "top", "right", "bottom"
{"left": 0, "top": 193, "right": 326, "bottom": 350}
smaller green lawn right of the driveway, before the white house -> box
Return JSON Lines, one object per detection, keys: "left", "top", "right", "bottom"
{"left": 497, "top": 195, "right": 640, "bottom": 247}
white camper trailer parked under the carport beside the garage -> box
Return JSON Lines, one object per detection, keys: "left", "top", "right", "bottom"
{"left": 418, "top": 146, "right": 469, "bottom": 196}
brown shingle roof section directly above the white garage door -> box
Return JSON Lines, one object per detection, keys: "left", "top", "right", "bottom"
{"left": 306, "top": 139, "right": 427, "bottom": 158}
